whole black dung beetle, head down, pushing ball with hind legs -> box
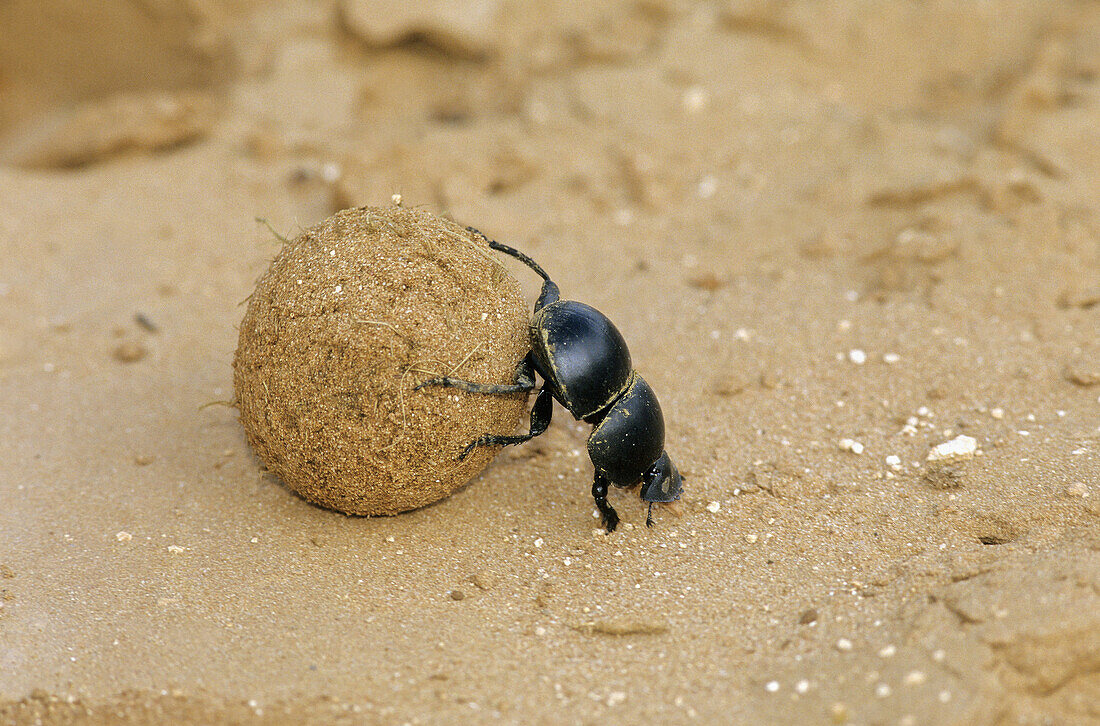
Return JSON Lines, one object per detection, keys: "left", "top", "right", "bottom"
{"left": 416, "top": 227, "right": 683, "bottom": 532}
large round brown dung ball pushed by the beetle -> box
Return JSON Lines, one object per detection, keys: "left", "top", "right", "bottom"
{"left": 233, "top": 207, "right": 529, "bottom": 515}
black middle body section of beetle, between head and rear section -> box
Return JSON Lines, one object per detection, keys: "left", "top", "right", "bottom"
{"left": 589, "top": 374, "right": 664, "bottom": 486}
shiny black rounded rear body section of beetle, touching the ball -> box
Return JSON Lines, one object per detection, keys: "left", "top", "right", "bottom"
{"left": 531, "top": 300, "right": 633, "bottom": 419}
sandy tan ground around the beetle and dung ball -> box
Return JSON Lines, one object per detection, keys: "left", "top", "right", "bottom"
{"left": 0, "top": 0, "right": 1100, "bottom": 725}
